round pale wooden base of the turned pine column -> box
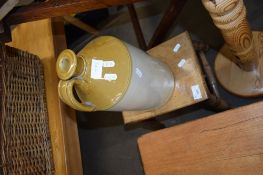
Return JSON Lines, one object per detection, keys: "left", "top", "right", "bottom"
{"left": 215, "top": 32, "right": 263, "bottom": 97}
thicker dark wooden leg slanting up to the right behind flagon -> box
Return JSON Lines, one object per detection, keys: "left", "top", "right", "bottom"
{"left": 148, "top": 0, "right": 187, "bottom": 49}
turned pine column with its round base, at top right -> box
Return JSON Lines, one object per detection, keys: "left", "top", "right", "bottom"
{"left": 202, "top": 0, "right": 263, "bottom": 97}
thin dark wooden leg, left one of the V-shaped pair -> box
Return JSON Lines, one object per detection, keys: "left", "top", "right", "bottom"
{"left": 127, "top": 4, "right": 147, "bottom": 50}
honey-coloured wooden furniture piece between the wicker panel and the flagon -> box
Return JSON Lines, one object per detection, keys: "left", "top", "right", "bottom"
{"left": 9, "top": 19, "right": 83, "bottom": 175}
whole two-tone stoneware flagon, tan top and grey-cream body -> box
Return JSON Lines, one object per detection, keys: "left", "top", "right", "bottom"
{"left": 56, "top": 36, "right": 174, "bottom": 111}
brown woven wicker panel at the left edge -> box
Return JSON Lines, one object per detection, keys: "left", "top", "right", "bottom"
{"left": 0, "top": 45, "right": 54, "bottom": 175}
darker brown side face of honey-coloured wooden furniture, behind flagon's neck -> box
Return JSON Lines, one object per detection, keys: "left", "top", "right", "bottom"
{"left": 52, "top": 17, "right": 83, "bottom": 175}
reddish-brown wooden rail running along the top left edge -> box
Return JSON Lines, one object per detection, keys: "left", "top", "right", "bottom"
{"left": 7, "top": 0, "right": 142, "bottom": 25}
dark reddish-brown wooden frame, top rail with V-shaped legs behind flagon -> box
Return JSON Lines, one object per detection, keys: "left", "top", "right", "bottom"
{"left": 0, "top": 0, "right": 190, "bottom": 50}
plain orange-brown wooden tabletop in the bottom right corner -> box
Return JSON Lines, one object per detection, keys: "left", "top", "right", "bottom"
{"left": 138, "top": 102, "right": 263, "bottom": 175}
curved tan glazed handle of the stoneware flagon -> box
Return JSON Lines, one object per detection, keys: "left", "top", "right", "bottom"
{"left": 58, "top": 79, "right": 96, "bottom": 112}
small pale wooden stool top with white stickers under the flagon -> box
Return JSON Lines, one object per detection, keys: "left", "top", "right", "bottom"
{"left": 123, "top": 32, "right": 208, "bottom": 124}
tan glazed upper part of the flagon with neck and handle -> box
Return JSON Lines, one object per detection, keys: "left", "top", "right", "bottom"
{"left": 56, "top": 36, "right": 132, "bottom": 111}
